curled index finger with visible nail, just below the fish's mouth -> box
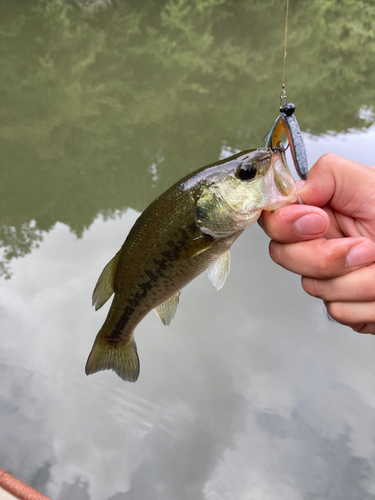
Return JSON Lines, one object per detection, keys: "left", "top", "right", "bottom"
{"left": 259, "top": 205, "right": 330, "bottom": 243}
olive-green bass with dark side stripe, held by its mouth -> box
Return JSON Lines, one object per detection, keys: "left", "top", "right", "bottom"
{"left": 85, "top": 143, "right": 297, "bottom": 382}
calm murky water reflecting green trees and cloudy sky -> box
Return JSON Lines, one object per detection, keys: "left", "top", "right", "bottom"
{"left": 0, "top": 0, "right": 375, "bottom": 500}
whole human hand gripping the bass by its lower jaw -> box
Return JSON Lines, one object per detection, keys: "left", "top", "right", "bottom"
{"left": 260, "top": 154, "right": 375, "bottom": 334}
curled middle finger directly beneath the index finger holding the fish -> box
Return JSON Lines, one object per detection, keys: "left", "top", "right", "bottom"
{"left": 269, "top": 238, "right": 375, "bottom": 279}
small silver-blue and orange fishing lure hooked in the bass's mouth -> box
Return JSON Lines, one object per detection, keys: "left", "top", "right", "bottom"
{"left": 265, "top": 102, "right": 308, "bottom": 180}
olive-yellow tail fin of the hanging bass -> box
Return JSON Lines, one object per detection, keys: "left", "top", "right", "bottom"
{"left": 85, "top": 338, "right": 139, "bottom": 382}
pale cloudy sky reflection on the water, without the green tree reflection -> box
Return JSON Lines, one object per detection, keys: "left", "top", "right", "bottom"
{"left": 0, "top": 129, "right": 375, "bottom": 500}
